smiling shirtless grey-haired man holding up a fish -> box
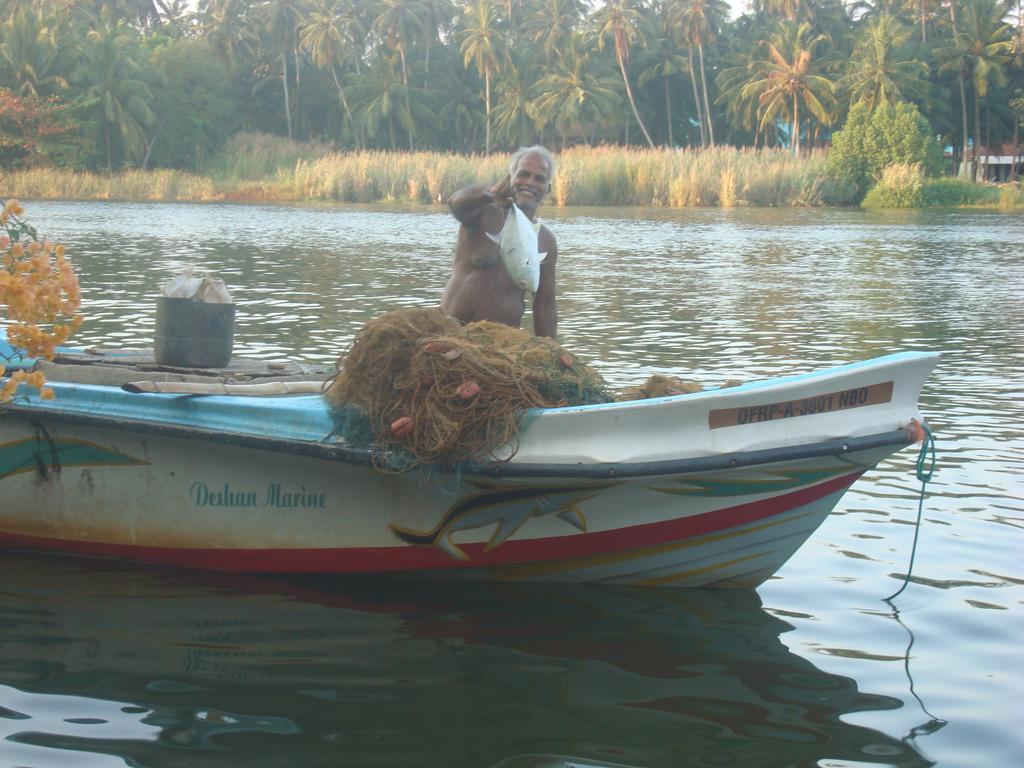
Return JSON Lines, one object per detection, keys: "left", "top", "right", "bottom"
{"left": 441, "top": 145, "right": 558, "bottom": 338}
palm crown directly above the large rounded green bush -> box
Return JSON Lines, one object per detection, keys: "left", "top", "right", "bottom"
{"left": 836, "top": 14, "right": 928, "bottom": 110}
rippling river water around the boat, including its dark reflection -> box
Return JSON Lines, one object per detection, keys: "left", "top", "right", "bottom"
{"left": 0, "top": 203, "right": 1024, "bottom": 768}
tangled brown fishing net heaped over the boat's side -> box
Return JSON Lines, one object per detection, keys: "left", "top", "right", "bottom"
{"left": 326, "top": 309, "right": 611, "bottom": 471}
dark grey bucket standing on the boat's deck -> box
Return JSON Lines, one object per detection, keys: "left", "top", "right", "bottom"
{"left": 153, "top": 296, "right": 234, "bottom": 368}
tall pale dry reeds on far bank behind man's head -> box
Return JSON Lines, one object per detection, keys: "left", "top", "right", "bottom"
{"left": 293, "top": 146, "right": 824, "bottom": 208}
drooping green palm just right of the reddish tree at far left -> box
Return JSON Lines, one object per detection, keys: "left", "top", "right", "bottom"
{"left": 74, "top": 14, "right": 155, "bottom": 172}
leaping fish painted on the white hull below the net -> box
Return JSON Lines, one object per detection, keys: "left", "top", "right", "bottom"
{"left": 391, "top": 484, "right": 608, "bottom": 560}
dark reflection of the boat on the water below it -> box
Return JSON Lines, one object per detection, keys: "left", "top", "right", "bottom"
{"left": 0, "top": 554, "right": 931, "bottom": 768}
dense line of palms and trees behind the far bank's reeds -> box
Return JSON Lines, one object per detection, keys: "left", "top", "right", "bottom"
{"left": 0, "top": 0, "right": 1024, "bottom": 176}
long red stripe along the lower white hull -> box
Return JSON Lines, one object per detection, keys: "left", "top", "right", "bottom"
{"left": 0, "top": 471, "right": 863, "bottom": 573}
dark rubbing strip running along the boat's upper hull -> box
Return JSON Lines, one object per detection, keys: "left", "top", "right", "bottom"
{"left": 0, "top": 402, "right": 915, "bottom": 479}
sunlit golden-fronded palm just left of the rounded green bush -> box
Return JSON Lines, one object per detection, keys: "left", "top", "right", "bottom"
{"left": 740, "top": 22, "right": 835, "bottom": 155}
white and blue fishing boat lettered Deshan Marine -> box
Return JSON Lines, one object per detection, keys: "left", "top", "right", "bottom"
{"left": 0, "top": 339, "right": 938, "bottom": 588}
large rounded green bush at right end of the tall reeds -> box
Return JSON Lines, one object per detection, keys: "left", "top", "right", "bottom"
{"left": 825, "top": 102, "right": 942, "bottom": 205}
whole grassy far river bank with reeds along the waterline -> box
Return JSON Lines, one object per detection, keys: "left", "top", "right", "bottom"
{"left": 3, "top": 142, "right": 1024, "bottom": 210}
